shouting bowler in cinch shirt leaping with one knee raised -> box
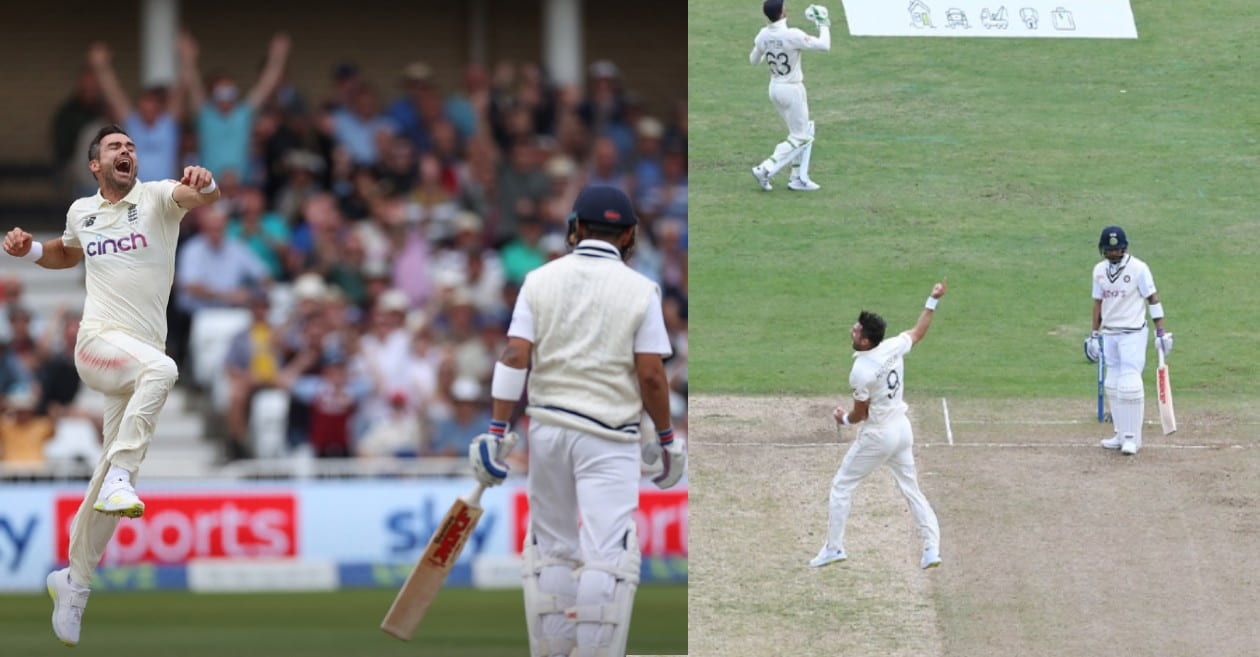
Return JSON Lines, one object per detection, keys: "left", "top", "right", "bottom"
{"left": 4, "top": 125, "right": 219, "bottom": 646}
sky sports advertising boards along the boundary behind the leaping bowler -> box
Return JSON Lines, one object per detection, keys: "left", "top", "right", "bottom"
{"left": 0, "top": 479, "right": 688, "bottom": 591}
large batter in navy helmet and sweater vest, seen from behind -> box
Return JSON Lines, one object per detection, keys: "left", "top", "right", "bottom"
{"left": 469, "top": 187, "right": 685, "bottom": 657}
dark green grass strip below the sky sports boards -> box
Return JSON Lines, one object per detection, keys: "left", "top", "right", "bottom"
{"left": 0, "top": 586, "right": 687, "bottom": 657}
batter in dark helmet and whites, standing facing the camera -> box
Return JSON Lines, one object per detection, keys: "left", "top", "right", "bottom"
{"left": 1085, "top": 226, "right": 1173, "bottom": 455}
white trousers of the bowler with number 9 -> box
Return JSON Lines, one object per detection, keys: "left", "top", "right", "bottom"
{"left": 827, "top": 414, "right": 941, "bottom": 550}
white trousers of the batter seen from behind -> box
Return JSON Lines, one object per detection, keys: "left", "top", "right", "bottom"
{"left": 528, "top": 422, "right": 640, "bottom": 653}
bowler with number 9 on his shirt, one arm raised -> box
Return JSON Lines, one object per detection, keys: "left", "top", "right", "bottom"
{"left": 809, "top": 280, "right": 945, "bottom": 569}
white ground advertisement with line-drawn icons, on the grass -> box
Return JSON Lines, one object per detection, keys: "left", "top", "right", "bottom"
{"left": 843, "top": 0, "right": 1138, "bottom": 39}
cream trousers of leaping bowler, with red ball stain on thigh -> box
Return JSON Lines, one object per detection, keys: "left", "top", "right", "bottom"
{"left": 69, "top": 330, "right": 179, "bottom": 586}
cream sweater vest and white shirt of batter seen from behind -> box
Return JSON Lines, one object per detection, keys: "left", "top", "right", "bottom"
{"left": 508, "top": 240, "right": 672, "bottom": 441}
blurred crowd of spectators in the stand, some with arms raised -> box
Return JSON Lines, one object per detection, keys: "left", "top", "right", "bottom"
{"left": 0, "top": 34, "right": 687, "bottom": 471}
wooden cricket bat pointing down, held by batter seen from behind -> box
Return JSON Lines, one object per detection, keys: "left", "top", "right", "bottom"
{"left": 381, "top": 483, "right": 485, "bottom": 641}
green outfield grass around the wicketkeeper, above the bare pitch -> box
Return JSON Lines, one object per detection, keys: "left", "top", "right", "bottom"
{"left": 689, "top": 0, "right": 1260, "bottom": 398}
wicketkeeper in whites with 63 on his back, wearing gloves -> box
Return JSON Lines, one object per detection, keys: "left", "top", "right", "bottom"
{"left": 748, "top": 0, "right": 832, "bottom": 192}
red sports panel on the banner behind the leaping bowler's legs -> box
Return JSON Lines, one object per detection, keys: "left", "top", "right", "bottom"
{"left": 57, "top": 493, "right": 297, "bottom": 565}
